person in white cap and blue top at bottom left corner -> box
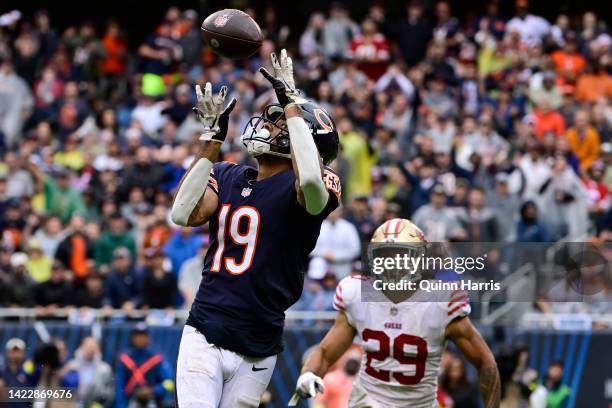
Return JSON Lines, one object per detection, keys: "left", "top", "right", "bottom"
{"left": 0, "top": 337, "right": 36, "bottom": 396}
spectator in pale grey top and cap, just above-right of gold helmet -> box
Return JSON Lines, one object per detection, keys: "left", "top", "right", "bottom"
{"left": 412, "top": 184, "right": 461, "bottom": 242}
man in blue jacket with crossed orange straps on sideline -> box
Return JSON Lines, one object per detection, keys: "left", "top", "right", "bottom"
{"left": 115, "top": 322, "right": 174, "bottom": 408}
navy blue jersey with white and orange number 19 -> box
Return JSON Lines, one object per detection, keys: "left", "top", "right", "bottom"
{"left": 187, "top": 162, "right": 340, "bottom": 357}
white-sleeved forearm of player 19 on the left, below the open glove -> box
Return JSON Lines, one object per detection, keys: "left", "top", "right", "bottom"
{"left": 171, "top": 141, "right": 221, "bottom": 226}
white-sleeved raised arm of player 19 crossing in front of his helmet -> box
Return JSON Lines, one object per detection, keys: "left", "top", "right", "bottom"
{"left": 285, "top": 104, "right": 329, "bottom": 214}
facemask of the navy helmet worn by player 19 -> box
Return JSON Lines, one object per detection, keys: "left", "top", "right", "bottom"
{"left": 240, "top": 105, "right": 291, "bottom": 159}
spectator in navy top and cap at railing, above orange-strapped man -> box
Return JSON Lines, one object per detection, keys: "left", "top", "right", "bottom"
{"left": 104, "top": 247, "right": 141, "bottom": 312}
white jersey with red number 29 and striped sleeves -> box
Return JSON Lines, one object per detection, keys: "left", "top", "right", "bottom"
{"left": 334, "top": 276, "right": 470, "bottom": 408}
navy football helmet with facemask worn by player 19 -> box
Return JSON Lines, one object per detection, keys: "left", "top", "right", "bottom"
{"left": 241, "top": 101, "right": 340, "bottom": 164}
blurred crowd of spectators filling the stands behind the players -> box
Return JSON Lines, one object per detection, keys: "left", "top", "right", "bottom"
{"left": 0, "top": 0, "right": 612, "bottom": 314}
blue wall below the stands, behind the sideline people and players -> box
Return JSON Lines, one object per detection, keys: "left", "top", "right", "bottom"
{"left": 0, "top": 322, "right": 612, "bottom": 408}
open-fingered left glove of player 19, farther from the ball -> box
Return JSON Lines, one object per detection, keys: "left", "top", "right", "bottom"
{"left": 193, "top": 82, "right": 236, "bottom": 143}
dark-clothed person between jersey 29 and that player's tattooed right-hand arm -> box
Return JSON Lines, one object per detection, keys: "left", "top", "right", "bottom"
{"left": 440, "top": 358, "right": 480, "bottom": 408}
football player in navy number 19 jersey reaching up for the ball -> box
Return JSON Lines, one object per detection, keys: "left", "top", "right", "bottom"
{"left": 171, "top": 50, "right": 340, "bottom": 408}
